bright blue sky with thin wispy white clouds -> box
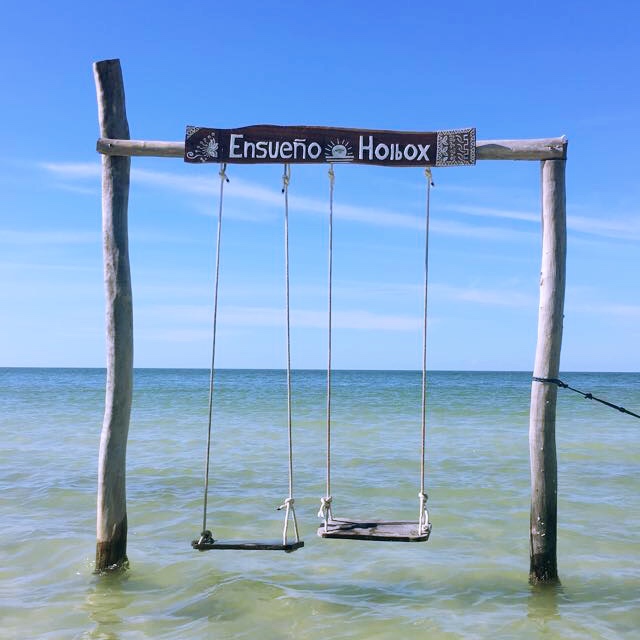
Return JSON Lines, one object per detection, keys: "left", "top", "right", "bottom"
{"left": 0, "top": 0, "right": 640, "bottom": 371}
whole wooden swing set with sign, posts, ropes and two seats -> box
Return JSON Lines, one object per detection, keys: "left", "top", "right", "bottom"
{"left": 94, "top": 60, "right": 567, "bottom": 583}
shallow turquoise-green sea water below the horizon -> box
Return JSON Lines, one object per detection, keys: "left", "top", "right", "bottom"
{"left": 0, "top": 369, "right": 640, "bottom": 639}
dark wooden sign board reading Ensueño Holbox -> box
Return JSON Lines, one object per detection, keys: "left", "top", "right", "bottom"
{"left": 184, "top": 124, "right": 476, "bottom": 167}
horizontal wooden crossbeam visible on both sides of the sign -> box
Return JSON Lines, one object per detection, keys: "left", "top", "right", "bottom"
{"left": 96, "top": 136, "right": 567, "bottom": 160}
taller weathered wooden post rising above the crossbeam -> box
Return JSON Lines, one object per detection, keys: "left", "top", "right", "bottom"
{"left": 93, "top": 60, "right": 133, "bottom": 572}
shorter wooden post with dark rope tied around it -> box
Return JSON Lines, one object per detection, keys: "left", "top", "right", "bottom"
{"left": 529, "top": 159, "right": 567, "bottom": 584}
